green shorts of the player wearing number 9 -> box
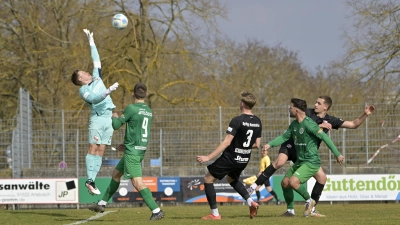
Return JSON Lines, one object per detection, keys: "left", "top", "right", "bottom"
{"left": 115, "top": 154, "right": 144, "bottom": 179}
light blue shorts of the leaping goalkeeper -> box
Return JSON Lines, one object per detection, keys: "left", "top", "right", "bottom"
{"left": 89, "top": 111, "right": 114, "bottom": 145}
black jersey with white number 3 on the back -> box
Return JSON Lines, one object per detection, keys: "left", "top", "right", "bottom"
{"left": 220, "top": 114, "right": 262, "bottom": 167}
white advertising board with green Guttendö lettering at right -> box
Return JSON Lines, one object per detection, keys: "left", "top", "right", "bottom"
{"left": 307, "top": 174, "right": 400, "bottom": 201}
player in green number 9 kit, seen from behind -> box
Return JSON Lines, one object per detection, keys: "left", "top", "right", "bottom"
{"left": 89, "top": 83, "right": 164, "bottom": 220}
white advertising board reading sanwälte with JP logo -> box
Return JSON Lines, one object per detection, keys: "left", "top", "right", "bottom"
{"left": 0, "top": 178, "right": 79, "bottom": 204}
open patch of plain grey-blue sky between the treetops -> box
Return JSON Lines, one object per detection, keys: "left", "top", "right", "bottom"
{"left": 219, "top": 0, "right": 351, "bottom": 69}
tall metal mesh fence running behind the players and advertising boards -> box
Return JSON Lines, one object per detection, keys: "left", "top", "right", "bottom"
{"left": 0, "top": 96, "right": 400, "bottom": 177}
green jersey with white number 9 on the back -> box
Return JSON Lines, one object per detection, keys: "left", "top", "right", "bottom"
{"left": 112, "top": 102, "right": 153, "bottom": 156}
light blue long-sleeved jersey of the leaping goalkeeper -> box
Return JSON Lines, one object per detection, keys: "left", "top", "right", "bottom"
{"left": 79, "top": 45, "right": 115, "bottom": 116}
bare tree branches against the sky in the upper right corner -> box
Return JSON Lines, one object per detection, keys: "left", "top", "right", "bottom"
{"left": 345, "top": 0, "right": 400, "bottom": 95}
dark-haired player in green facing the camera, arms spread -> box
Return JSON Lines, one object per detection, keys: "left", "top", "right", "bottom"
{"left": 263, "top": 98, "right": 344, "bottom": 216}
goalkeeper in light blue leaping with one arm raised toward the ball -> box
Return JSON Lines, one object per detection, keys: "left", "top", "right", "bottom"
{"left": 71, "top": 29, "right": 118, "bottom": 195}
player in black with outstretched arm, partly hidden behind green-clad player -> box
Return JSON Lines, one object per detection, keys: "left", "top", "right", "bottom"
{"left": 248, "top": 96, "right": 375, "bottom": 217}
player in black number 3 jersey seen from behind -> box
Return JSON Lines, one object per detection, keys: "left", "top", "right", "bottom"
{"left": 196, "top": 92, "right": 262, "bottom": 220}
